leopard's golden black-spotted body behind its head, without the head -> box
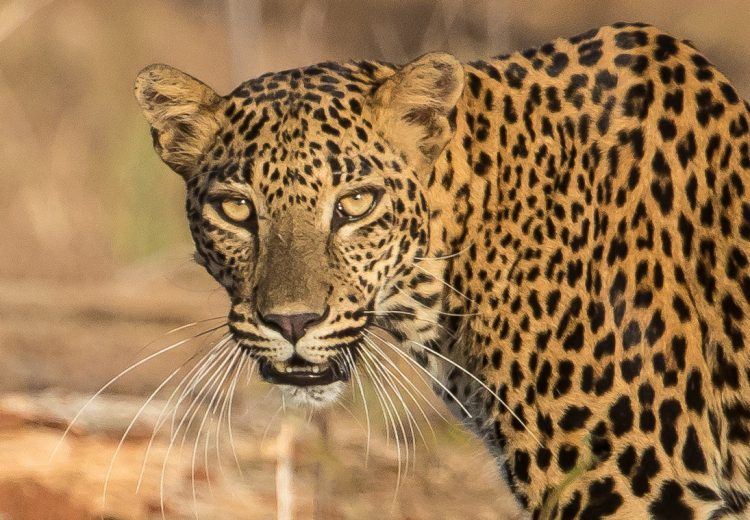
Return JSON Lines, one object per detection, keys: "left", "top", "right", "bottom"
{"left": 430, "top": 24, "right": 750, "bottom": 518}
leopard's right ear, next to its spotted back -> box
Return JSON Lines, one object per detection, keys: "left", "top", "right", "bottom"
{"left": 373, "top": 52, "right": 464, "bottom": 171}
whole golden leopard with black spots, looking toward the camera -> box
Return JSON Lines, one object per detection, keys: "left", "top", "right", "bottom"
{"left": 135, "top": 22, "right": 750, "bottom": 520}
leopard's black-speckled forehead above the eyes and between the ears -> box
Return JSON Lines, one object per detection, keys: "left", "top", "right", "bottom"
{"left": 211, "top": 62, "right": 398, "bottom": 211}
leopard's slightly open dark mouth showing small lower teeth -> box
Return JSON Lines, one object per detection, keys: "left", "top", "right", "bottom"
{"left": 260, "top": 354, "right": 349, "bottom": 386}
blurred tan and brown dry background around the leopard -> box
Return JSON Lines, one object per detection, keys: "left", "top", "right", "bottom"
{"left": 0, "top": 0, "right": 750, "bottom": 520}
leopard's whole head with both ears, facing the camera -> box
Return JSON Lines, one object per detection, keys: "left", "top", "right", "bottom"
{"left": 135, "top": 53, "right": 464, "bottom": 404}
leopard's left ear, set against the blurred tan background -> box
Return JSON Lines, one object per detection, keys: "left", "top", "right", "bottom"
{"left": 135, "top": 64, "right": 224, "bottom": 178}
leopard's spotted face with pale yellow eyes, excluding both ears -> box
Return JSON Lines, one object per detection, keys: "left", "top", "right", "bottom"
{"left": 188, "top": 86, "right": 427, "bottom": 406}
